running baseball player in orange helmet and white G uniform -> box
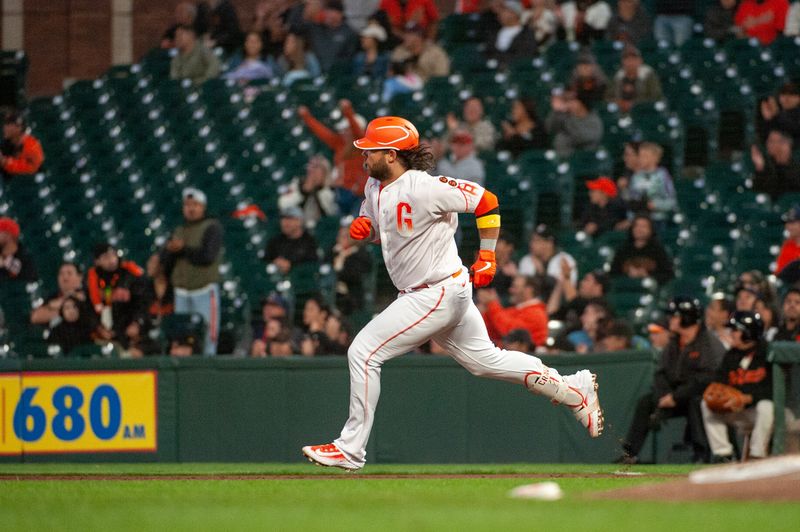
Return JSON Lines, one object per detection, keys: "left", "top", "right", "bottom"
{"left": 303, "top": 116, "right": 603, "bottom": 470}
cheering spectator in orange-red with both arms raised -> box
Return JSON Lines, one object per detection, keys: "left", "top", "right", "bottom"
{"left": 297, "top": 100, "right": 369, "bottom": 197}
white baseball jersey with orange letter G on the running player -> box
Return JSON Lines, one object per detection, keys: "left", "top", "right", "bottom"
{"left": 361, "top": 170, "right": 484, "bottom": 291}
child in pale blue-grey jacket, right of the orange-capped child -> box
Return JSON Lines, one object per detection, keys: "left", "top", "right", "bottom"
{"left": 630, "top": 142, "right": 677, "bottom": 227}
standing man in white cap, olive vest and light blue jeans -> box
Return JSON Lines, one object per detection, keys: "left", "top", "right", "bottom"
{"left": 161, "top": 188, "right": 223, "bottom": 356}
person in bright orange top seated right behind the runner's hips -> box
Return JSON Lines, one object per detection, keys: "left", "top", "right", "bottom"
{"left": 478, "top": 275, "right": 547, "bottom": 345}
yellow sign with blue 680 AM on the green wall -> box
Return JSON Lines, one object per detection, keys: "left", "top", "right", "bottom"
{"left": 0, "top": 371, "right": 157, "bottom": 454}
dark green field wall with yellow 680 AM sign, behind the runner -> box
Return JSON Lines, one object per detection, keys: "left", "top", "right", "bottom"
{"left": 0, "top": 351, "right": 668, "bottom": 463}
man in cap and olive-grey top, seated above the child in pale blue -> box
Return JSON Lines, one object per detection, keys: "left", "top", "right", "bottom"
{"left": 606, "top": 46, "right": 664, "bottom": 113}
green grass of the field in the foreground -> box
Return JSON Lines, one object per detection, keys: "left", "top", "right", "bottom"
{"left": 0, "top": 464, "right": 800, "bottom": 532}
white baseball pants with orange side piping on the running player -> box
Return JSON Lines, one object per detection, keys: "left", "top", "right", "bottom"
{"left": 334, "top": 271, "right": 557, "bottom": 466}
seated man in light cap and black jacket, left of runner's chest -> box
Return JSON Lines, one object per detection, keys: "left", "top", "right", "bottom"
{"left": 264, "top": 207, "right": 319, "bottom": 275}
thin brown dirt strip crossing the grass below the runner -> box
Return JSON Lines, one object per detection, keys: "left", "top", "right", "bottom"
{"left": 0, "top": 472, "right": 685, "bottom": 482}
